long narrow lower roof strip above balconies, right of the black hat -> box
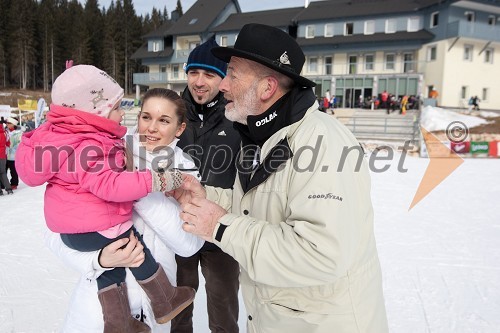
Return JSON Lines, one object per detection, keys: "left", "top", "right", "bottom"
{"left": 297, "top": 30, "right": 434, "bottom": 47}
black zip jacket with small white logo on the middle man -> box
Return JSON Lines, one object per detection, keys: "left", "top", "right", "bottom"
{"left": 177, "top": 87, "right": 241, "bottom": 188}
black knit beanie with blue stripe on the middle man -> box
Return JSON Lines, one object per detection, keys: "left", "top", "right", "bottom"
{"left": 184, "top": 38, "right": 227, "bottom": 78}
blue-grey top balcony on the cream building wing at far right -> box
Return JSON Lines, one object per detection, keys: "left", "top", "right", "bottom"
{"left": 446, "top": 21, "right": 500, "bottom": 42}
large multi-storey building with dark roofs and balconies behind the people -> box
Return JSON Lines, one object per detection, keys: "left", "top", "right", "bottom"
{"left": 134, "top": 0, "right": 500, "bottom": 109}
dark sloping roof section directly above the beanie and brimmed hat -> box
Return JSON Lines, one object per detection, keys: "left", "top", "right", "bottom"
{"left": 211, "top": 7, "right": 304, "bottom": 32}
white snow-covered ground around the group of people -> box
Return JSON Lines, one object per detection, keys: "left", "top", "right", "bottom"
{"left": 0, "top": 107, "right": 500, "bottom": 333}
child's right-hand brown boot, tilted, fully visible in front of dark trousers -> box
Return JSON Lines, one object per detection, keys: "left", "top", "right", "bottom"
{"left": 141, "top": 265, "right": 196, "bottom": 324}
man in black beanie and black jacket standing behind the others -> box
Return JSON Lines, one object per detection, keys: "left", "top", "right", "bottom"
{"left": 171, "top": 39, "right": 241, "bottom": 333}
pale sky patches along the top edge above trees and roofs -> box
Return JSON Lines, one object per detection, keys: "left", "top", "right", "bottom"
{"left": 79, "top": 0, "right": 305, "bottom": 15}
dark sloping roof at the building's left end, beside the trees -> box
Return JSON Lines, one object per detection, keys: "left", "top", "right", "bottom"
{"left": 167, "top": 0, "right": 240, "bottom": 36}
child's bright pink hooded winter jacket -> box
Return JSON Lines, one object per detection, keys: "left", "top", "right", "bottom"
{"left": 16, "top": 105, "right": 152, "bottom": 233}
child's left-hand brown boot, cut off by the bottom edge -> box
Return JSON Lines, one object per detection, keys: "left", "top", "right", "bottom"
{"left": 97, "top": 283, "right": 151, "bottom": 333}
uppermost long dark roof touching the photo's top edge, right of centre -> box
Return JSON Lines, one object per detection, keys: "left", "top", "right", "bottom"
{"left": 294, "top": 0, "right": 443, "bottom": 22}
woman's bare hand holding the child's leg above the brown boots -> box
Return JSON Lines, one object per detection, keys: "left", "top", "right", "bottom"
{"left": 99, "top": 231, "right": 144, "bottom": 268}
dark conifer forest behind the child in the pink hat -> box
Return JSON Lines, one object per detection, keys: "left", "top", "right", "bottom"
{"left": 0, "top": 0, "right": 182, "bottom": 93}
